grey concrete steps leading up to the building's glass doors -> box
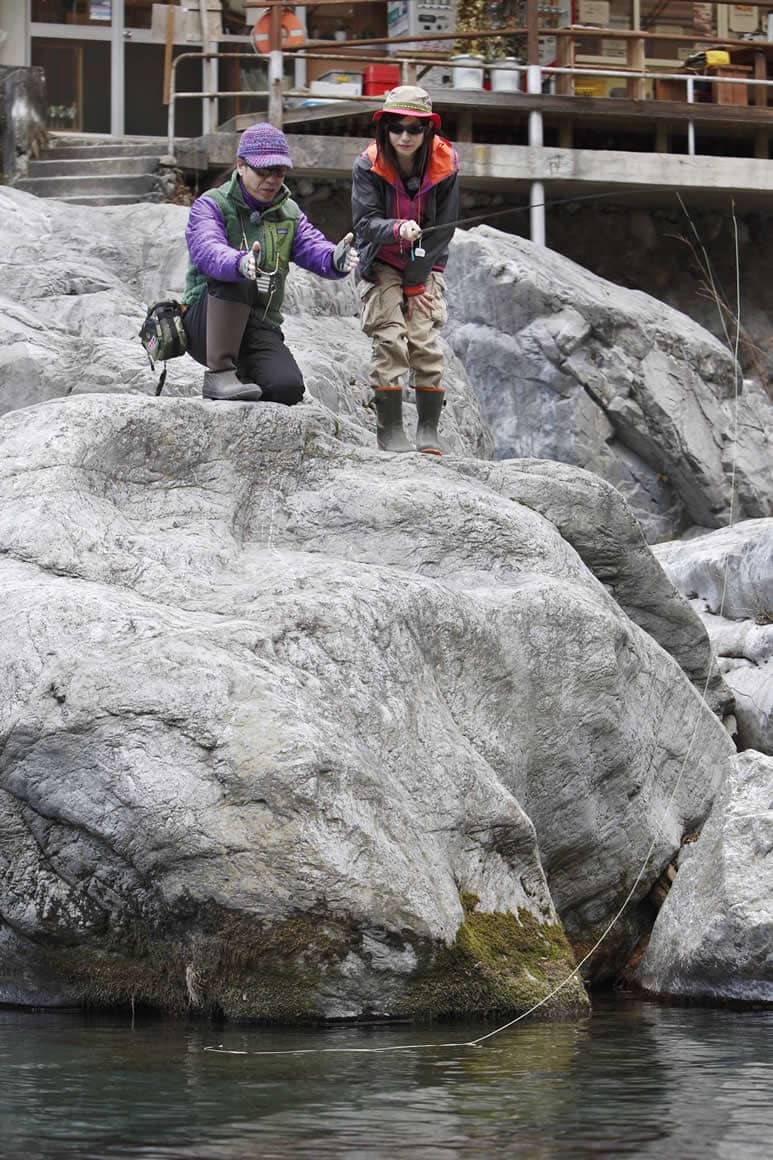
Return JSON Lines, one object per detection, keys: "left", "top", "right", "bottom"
{"left": 15, "top": 138, "right": 174, "bottom": 205}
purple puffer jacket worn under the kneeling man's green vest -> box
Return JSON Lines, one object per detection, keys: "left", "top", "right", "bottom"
{"left": 186, "top": 175, "right": 346, "bottom": 282}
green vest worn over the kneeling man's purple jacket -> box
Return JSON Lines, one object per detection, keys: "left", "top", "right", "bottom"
{"left": 182, "top": 172, "right": 301, "bottom": 329}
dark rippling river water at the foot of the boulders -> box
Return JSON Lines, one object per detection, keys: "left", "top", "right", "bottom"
{"left": 0, "top": 999, "right": 773, "bottom": 1160}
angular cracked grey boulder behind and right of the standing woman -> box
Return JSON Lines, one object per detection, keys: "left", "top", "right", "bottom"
{"left": 438, "top": 226, "right": 773, "bottom": 541}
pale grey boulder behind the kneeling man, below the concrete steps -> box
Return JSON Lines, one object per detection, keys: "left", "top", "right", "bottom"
{"left": 0, "top": 188, "right": 493, "bottom": 457}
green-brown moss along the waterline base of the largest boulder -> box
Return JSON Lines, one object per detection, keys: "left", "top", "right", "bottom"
{"left": 49, "top": 894, "right": 587, "bottom": 1023}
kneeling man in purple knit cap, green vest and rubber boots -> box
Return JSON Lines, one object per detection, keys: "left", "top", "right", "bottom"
{"left": 182, "top": 122, "right": 357, "bottom": 406}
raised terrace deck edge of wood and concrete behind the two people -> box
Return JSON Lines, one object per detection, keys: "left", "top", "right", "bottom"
{"left": 176, "top": 89, "right": 773, "bottom": 212}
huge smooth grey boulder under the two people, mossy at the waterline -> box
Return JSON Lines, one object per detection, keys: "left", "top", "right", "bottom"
{"left": 0, "top": 394, "right": 732, "bottom": 1017}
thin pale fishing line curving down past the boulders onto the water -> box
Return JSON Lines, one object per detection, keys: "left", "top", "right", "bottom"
{"left": 202, "top": 195, "right": 741, "bottom": 1056}
